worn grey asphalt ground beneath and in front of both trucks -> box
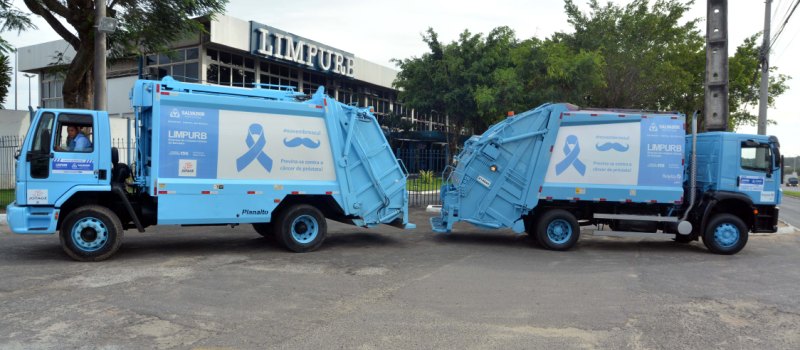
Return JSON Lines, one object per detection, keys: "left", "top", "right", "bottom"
{"left": 0, "top": 211, "right": 800, "bottom": 349}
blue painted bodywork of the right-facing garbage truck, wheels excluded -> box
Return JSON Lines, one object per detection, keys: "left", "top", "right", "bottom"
{"left": 431, "top": 104, "right": 780, "bottom": 232}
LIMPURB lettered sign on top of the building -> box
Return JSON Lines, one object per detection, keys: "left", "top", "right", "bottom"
{"left": 250, "top": 21, "right": 355, "bottom": 77}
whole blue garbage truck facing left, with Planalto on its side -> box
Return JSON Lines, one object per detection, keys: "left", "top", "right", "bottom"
{"left": 7, "top": 77, "right": 413, "bottom": 261}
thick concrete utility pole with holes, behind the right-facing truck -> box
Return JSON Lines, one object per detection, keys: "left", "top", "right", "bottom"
{"left": 704, "top": 0, "right": 728, "bottom": 131}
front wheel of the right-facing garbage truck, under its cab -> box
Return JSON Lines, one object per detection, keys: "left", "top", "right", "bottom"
{"left": 703, "top": 214, "right": 749, "bottom": 255}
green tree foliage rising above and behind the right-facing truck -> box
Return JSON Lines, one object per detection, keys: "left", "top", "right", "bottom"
{"left": 395, "top": 0, "right": 789, "bottom": 132}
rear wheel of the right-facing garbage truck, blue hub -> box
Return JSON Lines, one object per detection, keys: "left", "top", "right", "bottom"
{"left": 536, "top": 209, "right": 581, "bottom": 250}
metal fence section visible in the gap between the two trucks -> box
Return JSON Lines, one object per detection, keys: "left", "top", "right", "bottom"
{"left": 395, "top": 149, "right": 450, "bottom": 207}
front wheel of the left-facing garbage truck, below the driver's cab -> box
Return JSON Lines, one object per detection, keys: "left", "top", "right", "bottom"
{"left": 59, "top": 205, "right": 124, "bottom": 261}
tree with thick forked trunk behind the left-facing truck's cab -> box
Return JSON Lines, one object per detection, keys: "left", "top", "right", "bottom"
{"left": 24, "top": 0, "right": 227, "bottom": 108}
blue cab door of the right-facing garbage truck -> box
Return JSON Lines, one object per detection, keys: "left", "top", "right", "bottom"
{"left": 736, "top": 140, "right": 780, "bottom": 205}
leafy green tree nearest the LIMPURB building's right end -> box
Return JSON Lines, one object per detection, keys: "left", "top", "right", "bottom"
{"left": 394, "top": 27, "right": 604, "bottom": 142}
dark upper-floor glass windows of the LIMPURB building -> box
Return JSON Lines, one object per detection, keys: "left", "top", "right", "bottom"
{"left": 31, "top": 45, "right": 440, "bottom": 131}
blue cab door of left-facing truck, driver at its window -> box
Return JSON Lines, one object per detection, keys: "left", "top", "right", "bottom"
{"left": 25, "top": 111, "right": 99, "bottom": 205}
